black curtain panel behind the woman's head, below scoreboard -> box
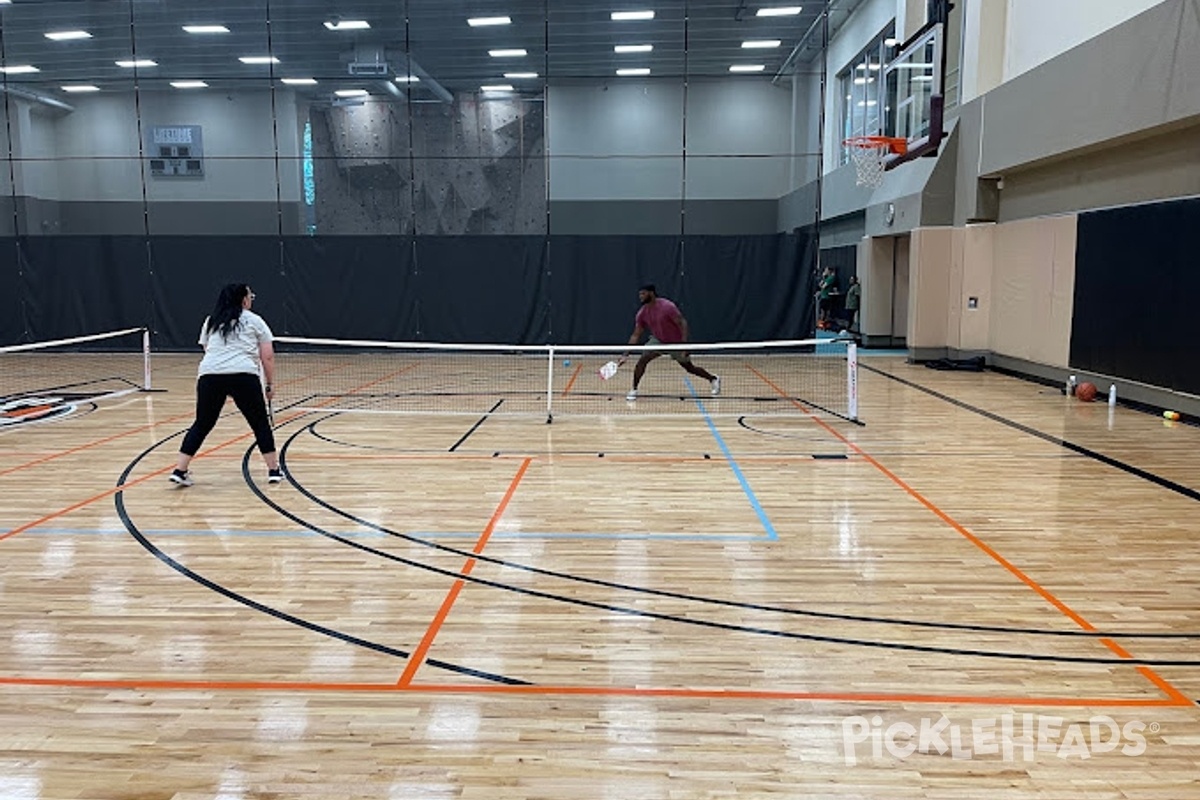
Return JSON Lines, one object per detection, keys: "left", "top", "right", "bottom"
{"left": 150, "top": 236, "right": 288, "bottom": 350}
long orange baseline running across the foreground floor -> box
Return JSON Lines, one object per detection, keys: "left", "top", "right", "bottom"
{"left": 0, "top": 675, "right": 1192, "bottom": 709}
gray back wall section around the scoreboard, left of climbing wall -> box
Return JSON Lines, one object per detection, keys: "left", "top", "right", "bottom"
{"left": 2, "top": 90, "right": 302, "bottom": 235}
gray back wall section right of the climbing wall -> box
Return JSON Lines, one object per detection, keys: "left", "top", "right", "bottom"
{"left": 547, "top": 78, "right": 793, "bottom": 234}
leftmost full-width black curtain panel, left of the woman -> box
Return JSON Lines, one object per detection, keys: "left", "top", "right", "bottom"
{"left": 20, "top": 236, "right": 150, "bottom": 341}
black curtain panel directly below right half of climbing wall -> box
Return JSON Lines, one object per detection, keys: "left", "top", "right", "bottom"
{"left": 416, "top": 236, "right": 548, "bottom": 344}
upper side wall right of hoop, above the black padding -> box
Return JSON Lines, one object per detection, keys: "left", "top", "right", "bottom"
{"left": 955, "top": 0, "right": 1200, "bottom": 223}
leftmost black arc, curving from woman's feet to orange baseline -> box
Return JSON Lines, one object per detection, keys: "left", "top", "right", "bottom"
{"left": 114, "top": 417, "right": 527, "bottom": 685}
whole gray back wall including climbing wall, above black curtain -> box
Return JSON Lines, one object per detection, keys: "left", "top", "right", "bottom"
{"left": 0, "top": 76, "right": 820, "bottom": 234}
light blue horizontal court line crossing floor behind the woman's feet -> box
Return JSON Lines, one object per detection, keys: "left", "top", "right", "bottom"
{"left": 9, "top": 528, "right": 764, "bottom": 542}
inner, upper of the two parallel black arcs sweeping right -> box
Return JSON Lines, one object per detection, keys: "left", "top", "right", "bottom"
{"left": 266, "top": 415, "right": 1200, "bottom": 647}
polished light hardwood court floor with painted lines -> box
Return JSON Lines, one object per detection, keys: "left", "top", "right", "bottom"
{"left": 0, "top": 354, "right": 1200, "bottom": 800}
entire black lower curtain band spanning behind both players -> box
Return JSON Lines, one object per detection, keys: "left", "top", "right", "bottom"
{"left": 0, "top": 231, "right": 814, "bottom": 351}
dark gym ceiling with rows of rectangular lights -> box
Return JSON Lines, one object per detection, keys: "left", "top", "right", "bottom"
{"left": 0, "top": 0, "right": 873, "bottom": 95}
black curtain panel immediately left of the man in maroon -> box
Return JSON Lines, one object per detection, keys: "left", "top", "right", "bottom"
{"left": 550, "top": 236, "right": 686, "bottom": 344}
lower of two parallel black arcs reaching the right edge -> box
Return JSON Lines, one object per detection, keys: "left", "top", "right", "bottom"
{"left": 262, "top": 431, "right": 1200, "bottom": 667}
